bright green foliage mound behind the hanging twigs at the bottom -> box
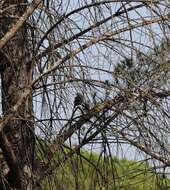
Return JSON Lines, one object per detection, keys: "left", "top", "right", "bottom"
{"left": 39, "top": 150, "right": 170, "bottom": 190}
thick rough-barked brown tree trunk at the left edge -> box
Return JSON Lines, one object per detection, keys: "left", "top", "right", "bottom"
{"left": 0, "top": 0, "right": 34, "bottom": 190}
